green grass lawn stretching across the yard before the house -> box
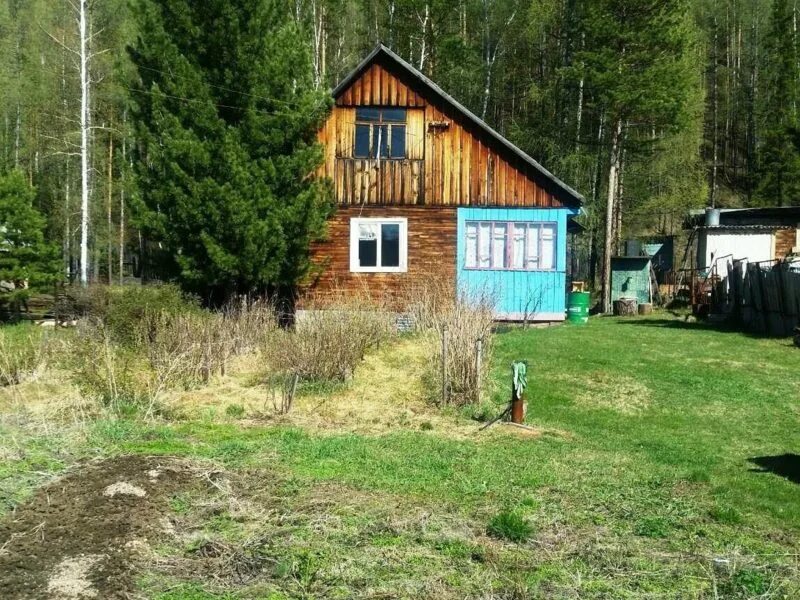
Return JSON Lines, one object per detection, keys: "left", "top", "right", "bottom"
{"left": 1, "top": 315, "right": 800, "bottom": 600}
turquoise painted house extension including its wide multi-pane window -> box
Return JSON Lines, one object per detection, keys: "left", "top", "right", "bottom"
{"left": 456, "top": 208, "right": 578, "bottom": 321}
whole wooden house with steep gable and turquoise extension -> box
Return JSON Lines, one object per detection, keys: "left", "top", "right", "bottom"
{"left": 309, "top": 45, "right": 583, "bottom": 320}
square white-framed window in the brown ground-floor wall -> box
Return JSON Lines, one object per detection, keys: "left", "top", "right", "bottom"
{"left": 350, "top": 217, "right": 408, "bottom": 273}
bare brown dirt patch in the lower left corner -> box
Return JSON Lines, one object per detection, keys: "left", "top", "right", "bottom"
{"left": 0, "top": 456, "right": 203, "bottom": 600}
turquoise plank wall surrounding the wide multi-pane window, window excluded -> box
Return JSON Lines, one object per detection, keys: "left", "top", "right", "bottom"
{"left": 456, "top": 208, "right": 578, "bottom": 321}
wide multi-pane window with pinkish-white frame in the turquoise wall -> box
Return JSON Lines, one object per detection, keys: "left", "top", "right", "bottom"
{"left": 464, "top": 221, "right": 558, "bottom": 271}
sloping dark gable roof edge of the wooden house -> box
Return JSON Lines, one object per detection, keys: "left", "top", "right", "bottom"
{"left": 333, "top": 44, "right": 584, "bottom": 207}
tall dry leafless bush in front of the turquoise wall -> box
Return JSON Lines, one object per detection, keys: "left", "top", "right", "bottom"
{"left": 408, "top": 282, "right": 495, "bottom": 405}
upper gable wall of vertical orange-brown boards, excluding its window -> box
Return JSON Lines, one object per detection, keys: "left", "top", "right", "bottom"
{"left": 319, "top": 64, "right": 562, "bottom": 208}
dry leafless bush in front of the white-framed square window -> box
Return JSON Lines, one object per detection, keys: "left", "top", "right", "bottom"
{"left": 263, "top": 295, "right": 395, "bottom": 381}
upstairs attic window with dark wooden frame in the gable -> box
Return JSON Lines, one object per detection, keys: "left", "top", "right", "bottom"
{"left": 353, "top": 108, "right": 406, "bottom": 158}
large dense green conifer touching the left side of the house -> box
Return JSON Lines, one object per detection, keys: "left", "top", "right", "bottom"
{"left": 131, "top": 0, "right": 331, "bottom": 303}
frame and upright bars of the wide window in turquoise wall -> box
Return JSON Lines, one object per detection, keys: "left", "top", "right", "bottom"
{"left": 463, "top": 219, "right": 559, "bottom": 273}
